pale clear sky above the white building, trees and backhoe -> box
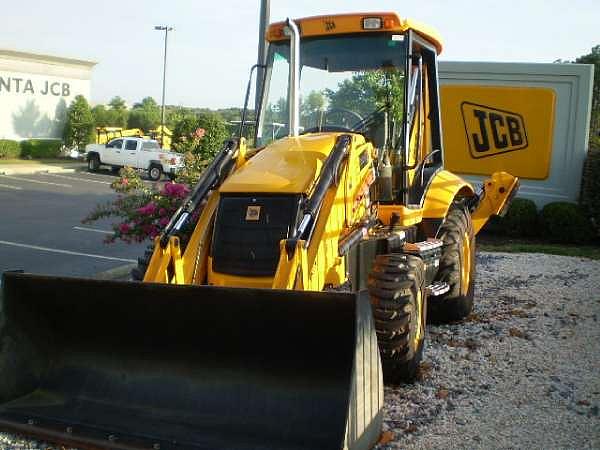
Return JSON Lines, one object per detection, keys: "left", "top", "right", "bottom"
{"left": 0, "top": 0, "right": 600, "bottom": 109}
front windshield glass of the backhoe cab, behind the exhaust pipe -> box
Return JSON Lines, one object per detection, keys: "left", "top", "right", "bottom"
{"left": 257, "top": 33, "right": 406, "bottom": 146}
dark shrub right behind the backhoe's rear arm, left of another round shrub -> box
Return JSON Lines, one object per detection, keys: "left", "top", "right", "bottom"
{"left": 485, "top": 198, "right": 538, "bottom": 237}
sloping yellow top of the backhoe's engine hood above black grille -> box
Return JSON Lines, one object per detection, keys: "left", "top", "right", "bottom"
{"left": 219, "top": 133, "right": 342, "bottom": 194}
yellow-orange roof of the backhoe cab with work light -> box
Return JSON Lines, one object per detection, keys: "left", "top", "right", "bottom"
{"left": 267, "top": 12, "right": 442, "bottom": 54}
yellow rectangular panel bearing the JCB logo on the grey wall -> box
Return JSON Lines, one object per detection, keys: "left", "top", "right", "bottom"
{"left": 441, "top": 85, "right": 556, "bottom": 180}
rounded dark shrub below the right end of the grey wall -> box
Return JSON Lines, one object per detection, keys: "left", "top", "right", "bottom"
{"left": 540, "top": 202, "right": 592, "bottom": 244}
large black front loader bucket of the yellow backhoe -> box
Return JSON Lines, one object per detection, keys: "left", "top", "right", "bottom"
{"left": 0, "top": 273, "right": 383, "bottom": 450}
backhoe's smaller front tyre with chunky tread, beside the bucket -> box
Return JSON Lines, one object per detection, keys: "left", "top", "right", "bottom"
{"left": 369, "top": 254, "right": 427, "bottom": 384}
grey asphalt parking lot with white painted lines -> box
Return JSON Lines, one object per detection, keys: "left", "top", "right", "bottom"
{"left": 0, "top": 170, "right": 158, "bottom": 277}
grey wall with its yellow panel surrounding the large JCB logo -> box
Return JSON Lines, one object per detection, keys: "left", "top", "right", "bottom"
{"left": 439, "top": 62, "right": 600, "bottom": 207}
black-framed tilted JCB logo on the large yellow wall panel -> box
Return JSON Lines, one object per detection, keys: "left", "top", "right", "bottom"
{"left": 461, "top": 102, "right": 528, "bottom": 158}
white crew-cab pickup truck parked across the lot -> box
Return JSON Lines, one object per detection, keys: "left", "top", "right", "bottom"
{"left": 85, "top": 138, "right": 183, "bottom": 181}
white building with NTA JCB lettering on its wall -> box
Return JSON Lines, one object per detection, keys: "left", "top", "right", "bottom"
{"left": 0, "top": 49, "right": 96, "bottom": 140}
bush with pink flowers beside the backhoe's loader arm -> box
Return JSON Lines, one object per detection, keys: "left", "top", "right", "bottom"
{"left": 82, "top": 168, "right": 193, "bottom": 243}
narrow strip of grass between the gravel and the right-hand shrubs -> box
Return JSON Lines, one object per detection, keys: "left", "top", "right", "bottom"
{"left": 477, "top": 235, "right": 600, "bottom": 259}
